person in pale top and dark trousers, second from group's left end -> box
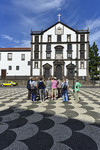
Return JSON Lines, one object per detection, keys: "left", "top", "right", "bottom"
{"left": 30, "top": 78, "right": 37, "bottom": 102}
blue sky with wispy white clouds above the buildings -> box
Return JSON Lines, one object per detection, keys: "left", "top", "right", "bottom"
{"left": 0, "top": 0, "right": 100, "bottom": 53}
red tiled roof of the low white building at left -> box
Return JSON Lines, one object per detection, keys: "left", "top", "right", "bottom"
{"left": 0, "top": 47, "right": 31, "bottom": 51}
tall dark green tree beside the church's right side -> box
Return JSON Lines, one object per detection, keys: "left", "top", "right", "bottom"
{"left": 89, "top": 42, "right": 100, "bottom": 80}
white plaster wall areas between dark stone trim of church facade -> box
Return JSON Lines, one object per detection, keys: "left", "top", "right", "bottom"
{"left": 32, "top": 23, "right": 88, "bottom": 79}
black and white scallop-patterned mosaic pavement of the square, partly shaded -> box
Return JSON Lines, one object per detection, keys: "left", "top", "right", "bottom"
{"left": 0, "top": 87, "right": 100, "bottom": 150}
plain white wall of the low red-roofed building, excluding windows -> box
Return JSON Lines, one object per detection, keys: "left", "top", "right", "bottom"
{"left": 0, "top": 51, "right": 31, "bottom": 76}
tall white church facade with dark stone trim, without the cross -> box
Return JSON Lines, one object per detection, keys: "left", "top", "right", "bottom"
{"left": 31, "top": 21, "right": 89, "bottom": 79}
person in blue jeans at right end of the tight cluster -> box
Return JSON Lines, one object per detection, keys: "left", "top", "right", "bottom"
{"left": 61, "top": 79, "right": 69, "bottom": 102}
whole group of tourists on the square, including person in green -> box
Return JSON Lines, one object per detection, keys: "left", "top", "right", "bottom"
{"left": 27, "top": 77, "right": 81, "bottom": 102}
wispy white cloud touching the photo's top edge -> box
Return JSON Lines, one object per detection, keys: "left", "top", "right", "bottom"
{"left": 12, "top": 0, "right": 66, "bottom": 13}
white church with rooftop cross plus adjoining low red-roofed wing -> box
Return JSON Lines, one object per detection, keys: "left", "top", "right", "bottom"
{"left": 0, "top": 16, "right": 89, "bottom": 79}
